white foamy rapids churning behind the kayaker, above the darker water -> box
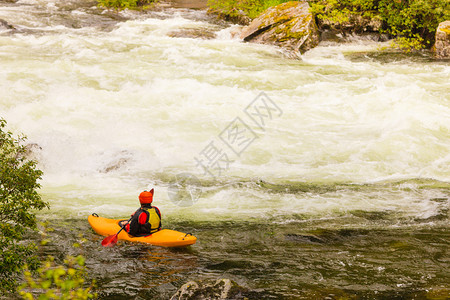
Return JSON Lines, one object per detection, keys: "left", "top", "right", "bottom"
{"left": 0, "top": 1, "right": 450, "bottom": 219}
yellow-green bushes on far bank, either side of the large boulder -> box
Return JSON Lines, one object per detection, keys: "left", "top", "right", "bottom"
{"left": 208, "top": 0, "right": 450, "bottom": 51}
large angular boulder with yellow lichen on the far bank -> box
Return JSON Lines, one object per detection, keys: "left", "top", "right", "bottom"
{"left": 241, "top": 1, "right": 319, "bottom": 53}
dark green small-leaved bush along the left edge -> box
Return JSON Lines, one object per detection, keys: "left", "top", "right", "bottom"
{"left": 0, "top": 119, "right": 48, "bottom": 291}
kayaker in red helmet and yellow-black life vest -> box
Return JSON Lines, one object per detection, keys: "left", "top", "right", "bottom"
{"left": 120, "top": 189, "right": 161, "bottom": 236}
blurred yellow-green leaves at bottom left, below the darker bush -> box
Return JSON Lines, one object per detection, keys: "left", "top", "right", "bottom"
{"left": 18, "top": 255, "right": 97, "bottom": 300}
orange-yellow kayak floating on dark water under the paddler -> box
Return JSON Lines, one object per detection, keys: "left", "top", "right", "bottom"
{"left": 88, "top": 213, "right": 197, "bottom": 247}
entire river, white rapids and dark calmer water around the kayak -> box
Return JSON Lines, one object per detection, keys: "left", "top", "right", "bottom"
{"left": 0, "top": 0, "right": 450, "bottom": 299}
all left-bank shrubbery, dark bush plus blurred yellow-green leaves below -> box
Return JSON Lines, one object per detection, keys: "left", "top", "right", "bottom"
{"left": 0, "top": 118, "right": 96, "bottom": 299}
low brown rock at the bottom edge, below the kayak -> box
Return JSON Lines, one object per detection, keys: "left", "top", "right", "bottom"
{"left": 170, "top": 278, "right": 251, "bottom": 300}
